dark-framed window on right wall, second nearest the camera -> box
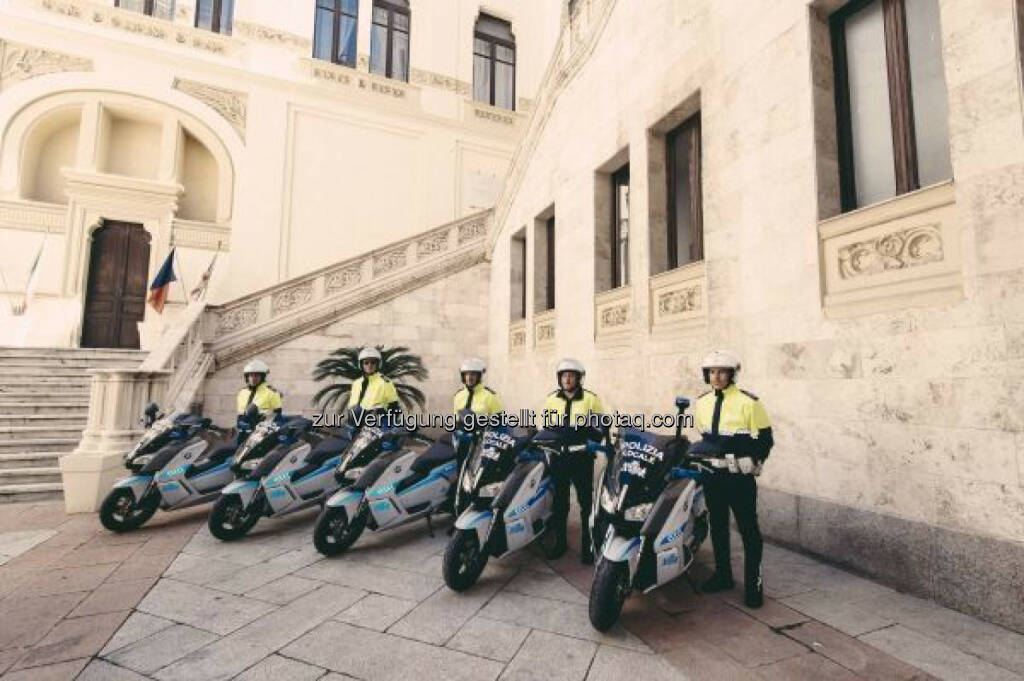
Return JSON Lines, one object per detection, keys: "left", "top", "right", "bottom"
{"left": 665, "top": 113, "right": 703, "bottom": 269}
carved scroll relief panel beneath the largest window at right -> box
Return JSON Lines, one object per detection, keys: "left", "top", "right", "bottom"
{"left": 838, "top": 224, "right": 943, "bottom": 279}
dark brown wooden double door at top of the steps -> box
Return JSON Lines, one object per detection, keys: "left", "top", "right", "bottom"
{"left": 81, "top": 220, "right": 151, "bottom": 348}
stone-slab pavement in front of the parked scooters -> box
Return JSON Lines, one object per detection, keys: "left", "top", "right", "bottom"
{"left": 0, "top": 497, "right": 1024, "bottom": 681}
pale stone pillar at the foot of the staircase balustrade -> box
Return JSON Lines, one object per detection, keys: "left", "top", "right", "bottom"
{"left": 60, "top": 369, "right": 170, "bottom": 513}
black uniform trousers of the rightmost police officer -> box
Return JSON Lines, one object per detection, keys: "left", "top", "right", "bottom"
{"left": 703, "top": 472, "right": 764, "bottom": 583}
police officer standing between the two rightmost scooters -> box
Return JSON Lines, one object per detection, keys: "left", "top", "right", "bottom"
{"left": 543, "top": 358, "right": 604, "bottom": 565}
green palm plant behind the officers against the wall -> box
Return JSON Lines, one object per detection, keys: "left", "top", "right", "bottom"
{"left": 313, "top": 345, "right": 430, "bottom": 409}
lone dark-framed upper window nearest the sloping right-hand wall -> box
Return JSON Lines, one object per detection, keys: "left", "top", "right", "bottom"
{"left": 473, "top": 14, "right": 515, "bottom": 110}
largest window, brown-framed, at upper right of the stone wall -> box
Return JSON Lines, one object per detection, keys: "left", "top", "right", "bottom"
{"left": 829, "top": 0, "right": 952, "bottom": 211}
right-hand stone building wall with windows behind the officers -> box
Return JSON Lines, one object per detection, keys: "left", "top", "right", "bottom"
{"left": 490, "top": 0, "right": 1024, "bottom": 629}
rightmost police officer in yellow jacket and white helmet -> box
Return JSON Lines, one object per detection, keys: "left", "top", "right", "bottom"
{"left": 690, "top": 350, "right": 773, "bottom": 607}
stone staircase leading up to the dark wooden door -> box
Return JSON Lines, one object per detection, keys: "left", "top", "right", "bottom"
{"left": 0, "top": 347, "right": 145, "bottom": 504}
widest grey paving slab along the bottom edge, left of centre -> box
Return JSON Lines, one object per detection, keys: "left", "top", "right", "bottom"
{"left": 282, "top": 622, "right": 503, "bottom": 681}
